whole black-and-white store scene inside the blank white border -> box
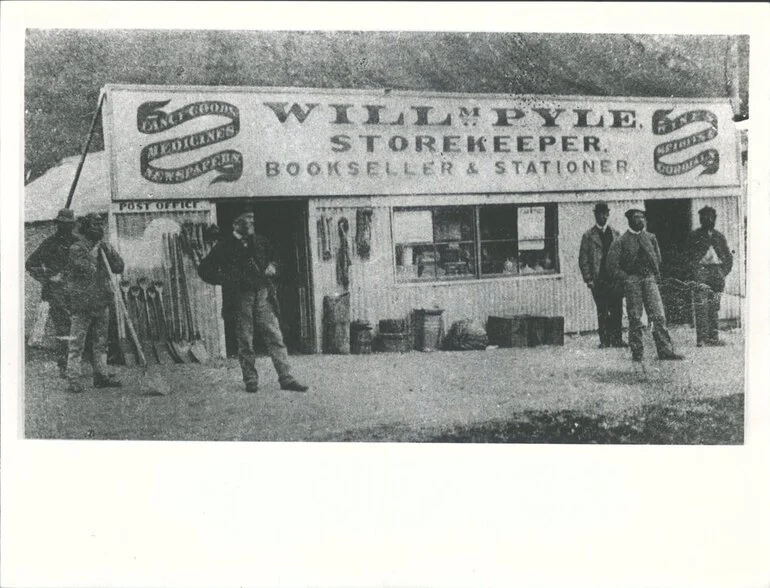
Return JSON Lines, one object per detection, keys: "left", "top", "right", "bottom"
{"left": 24, "top": 29, "right": 750, "bottom": 444}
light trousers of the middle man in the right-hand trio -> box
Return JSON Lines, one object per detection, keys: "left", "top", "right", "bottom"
{"left": 626, "top": 275, "right": 674, "bottom": 361}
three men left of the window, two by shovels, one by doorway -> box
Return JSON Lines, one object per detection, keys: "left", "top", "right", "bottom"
{"left": 26, "top": 208, "right": 308, "bottom": 392}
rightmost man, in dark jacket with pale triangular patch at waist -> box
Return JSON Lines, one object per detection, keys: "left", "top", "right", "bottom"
{"left": 685, "top": 206, "right": 733, "bottom": 347}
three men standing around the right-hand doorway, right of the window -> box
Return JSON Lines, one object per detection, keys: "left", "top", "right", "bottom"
{"left": 579, "top": 202, "right": 733, "bottom": 362}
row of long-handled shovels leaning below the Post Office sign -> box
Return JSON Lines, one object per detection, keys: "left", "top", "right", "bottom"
{"left": 111, "top": 223, "right": 212, "bottom": 365}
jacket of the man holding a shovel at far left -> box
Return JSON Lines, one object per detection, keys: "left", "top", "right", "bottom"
{"left": 64, "top": 238, "right": 125, "bottom": 314}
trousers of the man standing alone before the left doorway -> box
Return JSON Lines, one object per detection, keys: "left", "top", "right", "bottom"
{"left": 235, "top": 288, "right": 292, "bottom": 384}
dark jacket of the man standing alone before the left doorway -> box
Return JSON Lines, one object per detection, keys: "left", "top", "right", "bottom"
{"left": 198, "top": 233, "right": 278, "bottom": 291}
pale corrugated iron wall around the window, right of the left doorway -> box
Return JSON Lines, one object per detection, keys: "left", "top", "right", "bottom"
{"left": 310, "top": 194, "right": 745, "bottom": 349}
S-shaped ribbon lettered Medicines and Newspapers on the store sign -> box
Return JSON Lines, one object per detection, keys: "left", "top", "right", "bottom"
{"left": 136, "top": 100, "right": 243, "bottom": 184}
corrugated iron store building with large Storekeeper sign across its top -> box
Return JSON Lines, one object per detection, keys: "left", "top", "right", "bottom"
{"left": 103, "top": 85, "right": 745, "bottom": 354}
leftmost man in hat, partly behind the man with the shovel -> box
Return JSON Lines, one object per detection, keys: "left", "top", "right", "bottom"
{"left": 25, "top": 208, "right": 78, "bottom": 378}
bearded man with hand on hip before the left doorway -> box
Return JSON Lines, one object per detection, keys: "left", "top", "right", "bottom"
{"left": 198, "top": 212, "right": 308, "bottom": 392}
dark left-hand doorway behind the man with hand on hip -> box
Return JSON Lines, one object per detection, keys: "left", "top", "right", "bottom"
{"left": 217, "top": 200, "right": 314, "bottom": 356}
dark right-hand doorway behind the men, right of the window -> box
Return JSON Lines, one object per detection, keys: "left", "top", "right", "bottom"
{"left": 644, "top": 199, "right": 692, "bottom": 324}
